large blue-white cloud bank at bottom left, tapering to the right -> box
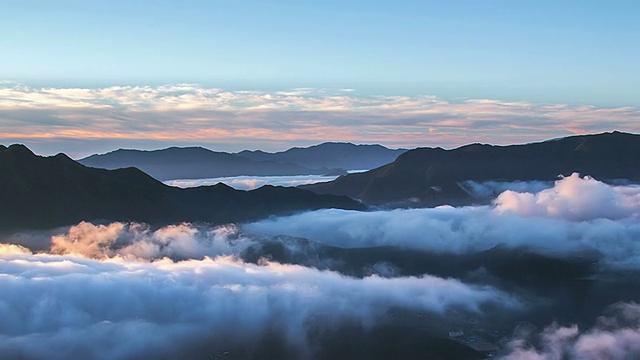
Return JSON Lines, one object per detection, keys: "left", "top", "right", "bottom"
{"left": 0, "top": 243, "right": 518, "bottom": 359}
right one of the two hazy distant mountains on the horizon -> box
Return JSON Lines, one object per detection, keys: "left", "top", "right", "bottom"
{"left": 236, "top": 142, "right": 407, "bottom": 170}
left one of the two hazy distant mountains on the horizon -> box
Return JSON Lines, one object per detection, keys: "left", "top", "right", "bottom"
{"left": 78, "top": 147, "right": 345, "bottom": 180}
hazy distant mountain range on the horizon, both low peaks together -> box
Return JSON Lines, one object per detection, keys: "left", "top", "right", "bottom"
{"left": 78, "top": 143, "right": 405, "bottom": 180}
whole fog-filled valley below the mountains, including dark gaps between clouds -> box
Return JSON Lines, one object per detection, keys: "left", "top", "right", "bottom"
{"left": 0, "top": 174, "right": 640, "bottom": 359}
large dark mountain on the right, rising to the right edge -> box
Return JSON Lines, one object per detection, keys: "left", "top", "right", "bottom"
{"left": 301, "top": 132, "right": 640, "bottom": 206}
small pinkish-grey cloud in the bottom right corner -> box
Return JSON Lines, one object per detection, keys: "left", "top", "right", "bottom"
{"left": 501, "top": 303, "right": 640, "bottom": 360}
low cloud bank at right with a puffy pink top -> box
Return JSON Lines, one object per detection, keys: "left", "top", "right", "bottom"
{"left": 244, "top": 174, "right": 640, "bottom": 269}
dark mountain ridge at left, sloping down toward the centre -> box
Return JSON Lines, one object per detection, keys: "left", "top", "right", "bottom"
{"left": 0, "top": 145, "right": 363, "bottom": 230}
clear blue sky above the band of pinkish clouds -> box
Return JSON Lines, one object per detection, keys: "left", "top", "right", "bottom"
{"left": 0, "top": 0, "right": 640, "bottom": 155}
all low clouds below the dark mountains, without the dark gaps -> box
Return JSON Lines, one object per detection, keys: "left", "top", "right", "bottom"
{"left": 0, "top": 174, "right": 640, "bottom": 359}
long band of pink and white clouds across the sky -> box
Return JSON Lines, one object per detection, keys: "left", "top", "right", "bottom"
{"left": 0, "top": 83, "right": 640, "bottom": 155}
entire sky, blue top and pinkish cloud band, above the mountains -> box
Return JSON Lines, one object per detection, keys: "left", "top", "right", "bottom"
{"left": 0, "top": 0, "right": 640, "bottom": 157}
